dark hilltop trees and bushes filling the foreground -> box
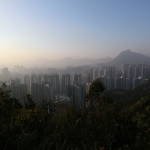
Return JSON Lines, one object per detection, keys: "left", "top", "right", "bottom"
{"left": 0, "top": 82, "right": 150, "bottom": 150}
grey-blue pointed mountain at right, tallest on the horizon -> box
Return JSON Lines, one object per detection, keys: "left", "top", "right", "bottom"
{"left": 108, "top": 50, "right": 150, "bottom": 67}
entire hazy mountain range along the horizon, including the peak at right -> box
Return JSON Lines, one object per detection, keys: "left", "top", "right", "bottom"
{"left": 26, "top": 50, "right": 150, "bottom": 68}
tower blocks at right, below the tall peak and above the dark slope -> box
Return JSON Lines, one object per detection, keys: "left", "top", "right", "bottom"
{"left": 87, "top": 64, "right": 150, "bottom": 90}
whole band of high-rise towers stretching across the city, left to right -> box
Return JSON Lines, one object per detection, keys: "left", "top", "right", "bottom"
{"left": 1, "top": 64, "right": 150, "bottom": 108}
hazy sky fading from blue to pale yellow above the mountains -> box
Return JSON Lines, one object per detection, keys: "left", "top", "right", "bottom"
{"left": 0, "top": 0, "right": 150, "bottom": 64}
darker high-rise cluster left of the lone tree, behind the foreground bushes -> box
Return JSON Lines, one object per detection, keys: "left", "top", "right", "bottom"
{"left": 5, "top": 73, "right": 84, "bottom": 107}
